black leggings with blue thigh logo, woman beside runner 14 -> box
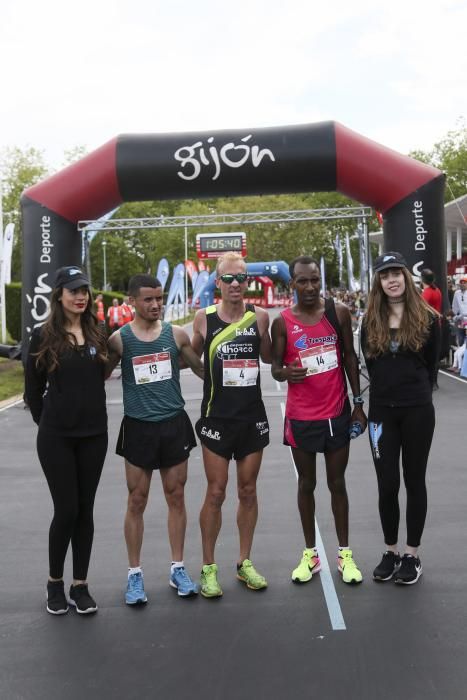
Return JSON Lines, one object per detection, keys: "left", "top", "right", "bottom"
{"left": 368, "top": 403, "right": 435, "bottom": 547}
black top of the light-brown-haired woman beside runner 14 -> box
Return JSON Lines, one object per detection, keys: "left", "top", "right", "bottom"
{"left": 361, "top": 316, "right": 440, "bottom": 406}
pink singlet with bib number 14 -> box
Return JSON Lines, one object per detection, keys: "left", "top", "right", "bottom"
{"left": 281, "top": 309, "right": 347, "bottom": 420}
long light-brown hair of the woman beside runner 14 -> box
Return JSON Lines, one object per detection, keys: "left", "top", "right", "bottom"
{"left": 363, "top": 267, "right": 437, "bottom": 357}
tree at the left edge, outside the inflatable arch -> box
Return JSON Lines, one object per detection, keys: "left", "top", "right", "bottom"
{"left": 0, "top": 147, "right": 48, "bottom": 281}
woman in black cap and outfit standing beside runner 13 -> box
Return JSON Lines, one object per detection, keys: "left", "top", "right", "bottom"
{"left": 26, "top": 267, "right": 107, "bottom": 615}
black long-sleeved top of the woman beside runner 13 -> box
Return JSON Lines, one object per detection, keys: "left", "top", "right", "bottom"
{"left": 25, "top": 329, "right": 107, "bottom": 437}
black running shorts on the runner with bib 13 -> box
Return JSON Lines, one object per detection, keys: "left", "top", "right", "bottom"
{"left": 119, "top": 411, "right": 196, "bottom": 469}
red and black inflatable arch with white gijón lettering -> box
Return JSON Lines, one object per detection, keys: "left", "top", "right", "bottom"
{"left": 21, "top": 122, "right": 447, "bottom": 339}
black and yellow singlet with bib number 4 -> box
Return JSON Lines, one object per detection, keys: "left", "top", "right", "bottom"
{"left": 201, "top": 304, "right": 266, "bottom": 420}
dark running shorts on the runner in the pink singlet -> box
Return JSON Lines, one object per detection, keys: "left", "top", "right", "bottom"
{"left": 284, "top": 409, "right": 350, "bottom": 452}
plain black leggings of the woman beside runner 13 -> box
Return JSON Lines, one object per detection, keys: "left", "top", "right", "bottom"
{"left": 37, "top": 430, "right": 107, "bottom": 581}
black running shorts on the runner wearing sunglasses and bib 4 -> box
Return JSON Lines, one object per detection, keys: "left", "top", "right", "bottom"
{"left": 195, "top": 417, "right": 269, "bottom": 461}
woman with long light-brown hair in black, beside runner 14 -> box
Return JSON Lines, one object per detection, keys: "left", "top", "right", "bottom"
{"left": 362, "top": 252, "right": 439, "bottom": 584}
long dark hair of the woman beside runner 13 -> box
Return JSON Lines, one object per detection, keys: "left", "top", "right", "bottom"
{"left": 36, "top": 287, "right": 108, "bottom": 372}
